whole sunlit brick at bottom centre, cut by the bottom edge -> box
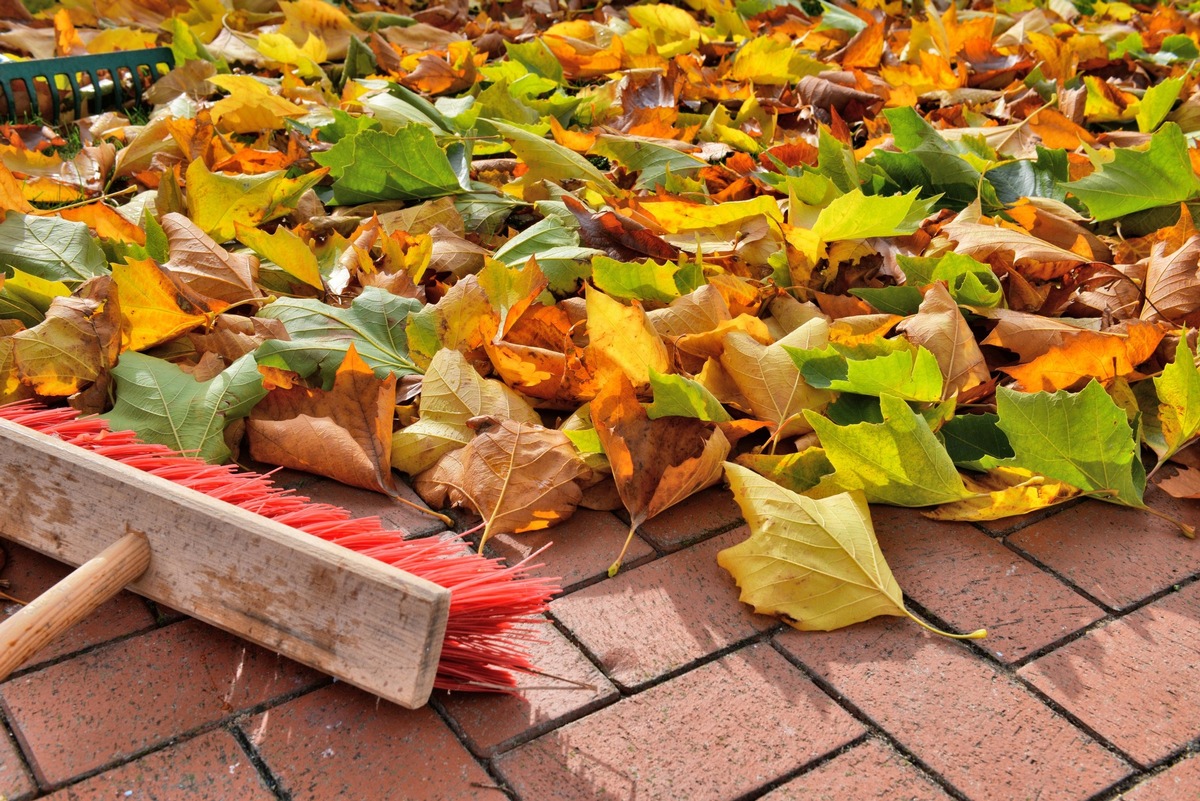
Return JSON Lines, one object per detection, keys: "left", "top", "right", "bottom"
{"left": 496, "top": 644, "right": 863, "bottom": 801}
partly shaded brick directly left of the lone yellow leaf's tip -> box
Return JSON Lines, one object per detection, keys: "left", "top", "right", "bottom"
{"left": 550, "top": 528, "right": 775, "bottom": 687}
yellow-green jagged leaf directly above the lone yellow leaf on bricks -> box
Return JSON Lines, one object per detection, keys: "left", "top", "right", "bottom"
{"left": 805, "top": 395, "right": 971, "bottom": 506}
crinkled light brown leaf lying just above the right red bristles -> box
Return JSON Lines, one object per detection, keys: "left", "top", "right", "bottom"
{"left": 413, "top": 417, "right": 592, "bottom": 548}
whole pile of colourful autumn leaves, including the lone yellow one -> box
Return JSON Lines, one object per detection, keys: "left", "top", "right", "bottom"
{"left": 0, "top": 0, "right": 1200, "bottom": 630}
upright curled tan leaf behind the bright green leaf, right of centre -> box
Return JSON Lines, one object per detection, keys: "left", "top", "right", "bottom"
{"left": 896, "top": 282, "right": 991, "bottom": 398}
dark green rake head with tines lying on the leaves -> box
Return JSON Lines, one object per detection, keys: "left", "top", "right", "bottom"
{"left": 0, "top": 47, "right": 175, "bottom": 124}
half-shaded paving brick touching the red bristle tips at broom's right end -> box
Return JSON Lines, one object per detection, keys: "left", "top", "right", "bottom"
{"left": 437, "top": 626, "right": 617, "bottom": 755}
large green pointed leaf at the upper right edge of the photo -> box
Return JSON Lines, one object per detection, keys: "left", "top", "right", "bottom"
{"left": 1063, "top": 122, "right": 1200, "bottom": 221}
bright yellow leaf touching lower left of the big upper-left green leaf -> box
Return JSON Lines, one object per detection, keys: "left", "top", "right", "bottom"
{"left": 187, "top": 158, "right": 329, "bottom": 242}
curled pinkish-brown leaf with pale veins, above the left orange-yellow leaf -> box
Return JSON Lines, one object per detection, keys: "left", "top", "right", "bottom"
{"left": 162, "top": 212, "right": 263, "bottom": 303}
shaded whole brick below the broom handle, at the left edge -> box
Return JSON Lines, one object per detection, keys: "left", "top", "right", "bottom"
{"left": 0, "top": 620, "right": 324, "bottom": 784}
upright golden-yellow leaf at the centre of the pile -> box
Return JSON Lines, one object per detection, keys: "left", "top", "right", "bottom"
{"left": 587, "top": 285, "right": 671, "bottom": 390}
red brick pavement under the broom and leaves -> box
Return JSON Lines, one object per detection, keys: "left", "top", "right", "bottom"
{"left": 0, "top": 480, "right": 1200, "bottom": 801}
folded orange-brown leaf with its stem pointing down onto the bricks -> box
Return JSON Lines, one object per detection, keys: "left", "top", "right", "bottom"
{"left": 592, "top": 375, "right": 730, "bottom": 576}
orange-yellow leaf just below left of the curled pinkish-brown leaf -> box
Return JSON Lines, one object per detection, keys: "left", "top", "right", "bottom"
{"left": 113, "top": 259, "right": 228, "bottom": 350}
